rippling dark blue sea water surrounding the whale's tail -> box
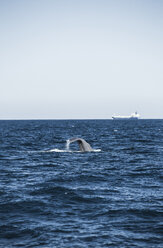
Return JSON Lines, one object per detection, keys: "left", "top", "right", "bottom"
{"left": 0, "top": 120, "right": 163, "bottom": 248}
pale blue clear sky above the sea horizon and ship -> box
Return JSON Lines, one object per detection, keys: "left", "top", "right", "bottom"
{"left": 0, "top": 0, "right": 163, "bottom": 119}
